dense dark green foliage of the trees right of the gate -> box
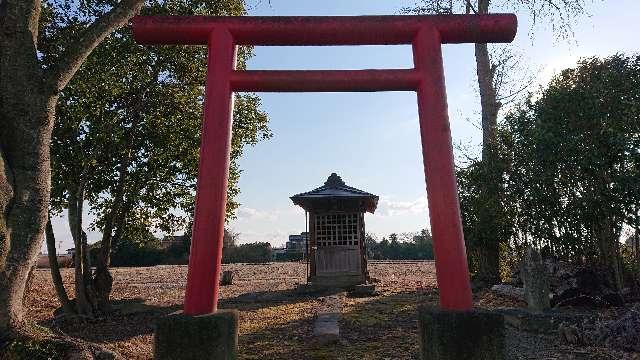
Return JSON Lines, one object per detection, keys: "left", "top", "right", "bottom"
{"left": 458, "top": 55, "right": 640, "bottom": 285}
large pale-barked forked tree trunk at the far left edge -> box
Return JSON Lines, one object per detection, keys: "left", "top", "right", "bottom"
{"left": 0, "top": 0, "right": 144, "bottom": 338}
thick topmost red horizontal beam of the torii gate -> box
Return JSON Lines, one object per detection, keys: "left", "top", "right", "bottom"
{"left": 133, "top": 14, "right": 517, "bottom": 46}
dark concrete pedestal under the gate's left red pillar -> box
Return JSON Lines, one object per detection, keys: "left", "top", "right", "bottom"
{"left": 154, "top": 310, "right": 238, "bottom": 360}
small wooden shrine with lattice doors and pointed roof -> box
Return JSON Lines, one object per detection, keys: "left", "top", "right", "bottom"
{"left": 291, "top": 173, "right": 378, "bottom": 287}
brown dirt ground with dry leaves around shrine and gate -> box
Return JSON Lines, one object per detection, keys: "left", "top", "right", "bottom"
{"left": 26, "top": 262, "right": 640, "bottom": 360}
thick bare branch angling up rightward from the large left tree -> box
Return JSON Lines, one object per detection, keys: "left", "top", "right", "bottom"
{"left": 46, "top": 0, "right": 144, "bottom": 92}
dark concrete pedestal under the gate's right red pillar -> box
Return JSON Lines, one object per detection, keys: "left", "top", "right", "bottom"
{"left": 418, "top": 307, "right": 505, "bottom": 360}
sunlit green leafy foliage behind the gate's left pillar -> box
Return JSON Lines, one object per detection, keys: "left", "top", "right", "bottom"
{"left": 43, "top": 0, "right": 271, "bottom": 240}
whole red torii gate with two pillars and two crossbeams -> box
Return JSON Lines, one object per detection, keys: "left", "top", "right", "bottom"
{"left": 133, "top": 14, "right": 517, "bottom": 315}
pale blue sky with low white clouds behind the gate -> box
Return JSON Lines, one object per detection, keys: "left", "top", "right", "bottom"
{"left": 54, "top": 0, "right": 640, "bottom": 248}
